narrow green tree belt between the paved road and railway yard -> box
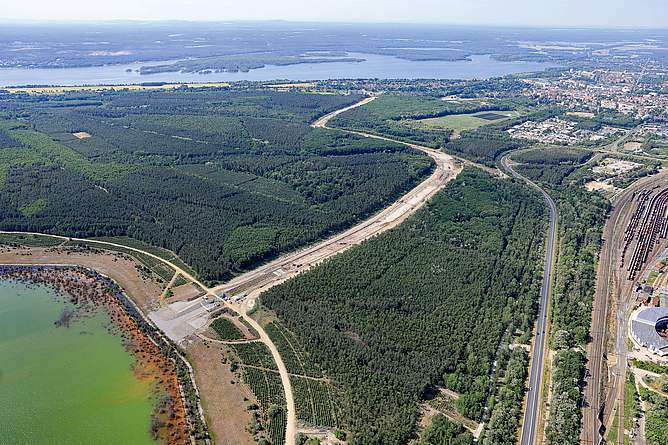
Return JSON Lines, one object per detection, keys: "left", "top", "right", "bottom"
{"left": 513, "top": 150, "right": 610, "bottom": 444}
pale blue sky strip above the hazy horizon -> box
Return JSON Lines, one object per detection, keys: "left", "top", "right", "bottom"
{"left": 0, "top": 0, "right": 668, "bottom": 28}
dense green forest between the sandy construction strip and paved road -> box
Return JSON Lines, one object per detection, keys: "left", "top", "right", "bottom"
{"left": 261, "top": 168, "right": 545, "bottom": 444}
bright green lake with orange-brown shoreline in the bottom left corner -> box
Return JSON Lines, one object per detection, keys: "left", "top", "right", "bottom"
{"left": 0, "top": 278, "right": 158, "bottom": 444}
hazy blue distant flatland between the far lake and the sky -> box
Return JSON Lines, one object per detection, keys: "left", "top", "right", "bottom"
{"left": 0, "top": 21, "right": 668, "bottom": 69}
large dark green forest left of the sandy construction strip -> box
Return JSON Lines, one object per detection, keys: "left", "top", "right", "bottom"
{"left": 0, "top": 84, "right": 434, "bottom": 280}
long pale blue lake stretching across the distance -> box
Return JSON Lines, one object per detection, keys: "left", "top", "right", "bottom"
{"left": 0, "top": 53, "right": 558, "bottom": 88}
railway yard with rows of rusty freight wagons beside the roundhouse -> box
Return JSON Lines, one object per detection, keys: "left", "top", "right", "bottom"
{"left": 582, "top": 173, "right": 668, "bottom": 444}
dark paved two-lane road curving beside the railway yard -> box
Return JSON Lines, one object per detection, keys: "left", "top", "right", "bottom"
{"left": 501, "top": 150, "right": 557, "bottom": 445}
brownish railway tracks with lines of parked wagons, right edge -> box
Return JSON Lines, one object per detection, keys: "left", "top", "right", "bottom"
{"left": 581, "top": 174, "right": 668, "bottom": 445}
